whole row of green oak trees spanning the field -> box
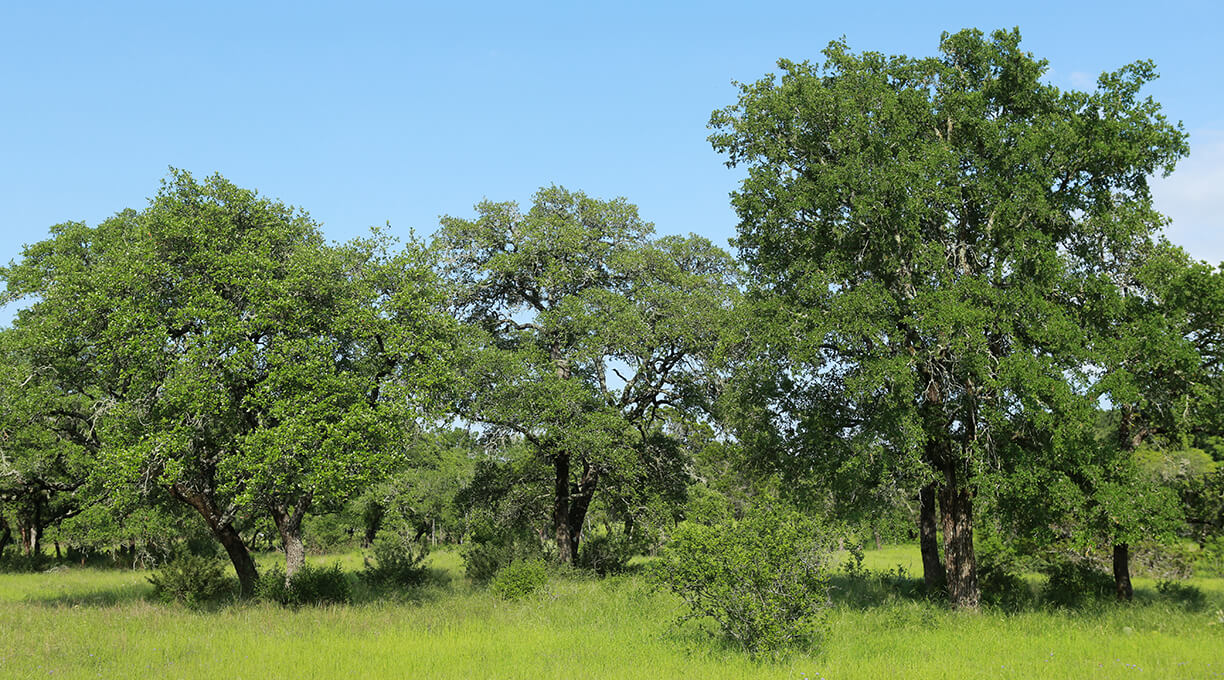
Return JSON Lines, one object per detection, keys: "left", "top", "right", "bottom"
{"left": 0, "top": 31, "right": 1224, "bottom": 608}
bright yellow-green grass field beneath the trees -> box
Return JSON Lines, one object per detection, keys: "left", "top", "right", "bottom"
{"left": 0, "top": 547, "right": 1224, "bottom": 680}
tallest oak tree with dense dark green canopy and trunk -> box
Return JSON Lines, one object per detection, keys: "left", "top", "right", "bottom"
{"left": 710, "top": 31, "right": 1187, "bottom": 607}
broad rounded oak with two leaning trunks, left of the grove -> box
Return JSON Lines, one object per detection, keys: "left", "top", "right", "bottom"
{"left": 4, "top": 171, "right": 454, "bottom": 593}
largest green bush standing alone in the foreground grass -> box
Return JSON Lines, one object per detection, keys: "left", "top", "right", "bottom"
{"left": 649, "top": 508, "right": 834, "bottom": 654}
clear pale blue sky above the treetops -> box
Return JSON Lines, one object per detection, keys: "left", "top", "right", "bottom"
{"left": 0, "top": 0, "right": 1224, "bottom": 320}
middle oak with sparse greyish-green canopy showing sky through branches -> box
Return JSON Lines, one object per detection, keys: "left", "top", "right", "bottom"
{"left": 436, "top": 187, "right": 737, "bottom": 563}
